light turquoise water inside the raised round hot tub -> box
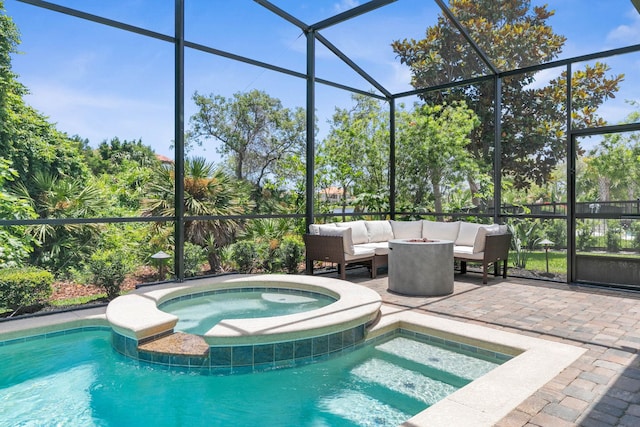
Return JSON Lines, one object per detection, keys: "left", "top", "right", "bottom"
{"left": 159, "top": 289, "right": 335, "bottom": 335}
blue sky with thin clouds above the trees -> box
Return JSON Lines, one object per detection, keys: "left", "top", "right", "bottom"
{"left": 5, "top": 0, "right": 640, "bottom": 161}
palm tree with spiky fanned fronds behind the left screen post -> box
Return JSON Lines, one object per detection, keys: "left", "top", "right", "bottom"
{"left": 143, "top": 157, "right": 253, "bottom": 271}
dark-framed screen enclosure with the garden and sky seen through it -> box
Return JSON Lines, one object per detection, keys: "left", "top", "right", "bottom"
{"left": 0, "top": 0, "right": 640, "bottom": 288}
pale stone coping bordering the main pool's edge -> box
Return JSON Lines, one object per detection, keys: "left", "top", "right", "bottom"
{"left": 0, "top": 276, "right": 587, "bottom": 427}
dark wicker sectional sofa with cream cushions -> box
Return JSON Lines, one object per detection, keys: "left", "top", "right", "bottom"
{"left": 304, "top": 220, "right": 511, "bottom": 283}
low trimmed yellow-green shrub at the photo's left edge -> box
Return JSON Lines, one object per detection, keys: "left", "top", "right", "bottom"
{"left": 0, "top": 267, "right": 53, "bottom": 311}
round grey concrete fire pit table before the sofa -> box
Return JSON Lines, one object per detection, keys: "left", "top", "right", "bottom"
{"left": 389, "top": 239, "right": 453, "bottom": 296}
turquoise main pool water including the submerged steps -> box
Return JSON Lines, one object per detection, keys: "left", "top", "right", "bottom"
{"left": 0, "top": 331, "right": 499, "bottom": 427}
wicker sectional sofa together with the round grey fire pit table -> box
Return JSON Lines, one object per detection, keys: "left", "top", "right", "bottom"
{"left": 304, "top": 220, "right": 511, "bottom": 295}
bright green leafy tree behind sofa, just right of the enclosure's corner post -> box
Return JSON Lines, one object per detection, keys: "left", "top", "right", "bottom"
{"left": 396, "top": 103, "right": 478, "bottom": 212}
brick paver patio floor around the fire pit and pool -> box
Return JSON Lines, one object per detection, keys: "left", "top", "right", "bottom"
{"left": 342, "top": 268, "right": 640, "bottom": 427}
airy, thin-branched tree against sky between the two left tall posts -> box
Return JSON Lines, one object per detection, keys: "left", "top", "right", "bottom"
{"left": 187, "top": 90, "right": 306, "bottom": 207}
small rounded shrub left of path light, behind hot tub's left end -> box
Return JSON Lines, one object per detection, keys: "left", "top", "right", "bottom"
{"left": 88, "top": 250, "right": 132, "bottom": 300}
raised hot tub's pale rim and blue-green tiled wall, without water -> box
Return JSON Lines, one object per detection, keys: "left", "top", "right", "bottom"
{"left": 106, "top": 275, "right": 382, "bottom": 374}
